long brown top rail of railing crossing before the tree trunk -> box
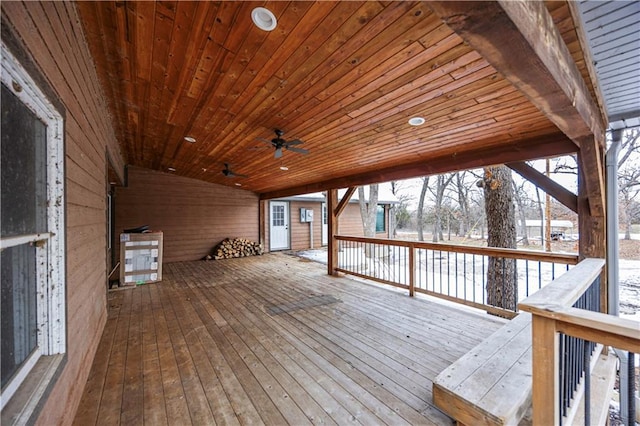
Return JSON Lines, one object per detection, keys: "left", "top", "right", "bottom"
{"left": 335, "top": 235, "right": 579, "bottom": 265}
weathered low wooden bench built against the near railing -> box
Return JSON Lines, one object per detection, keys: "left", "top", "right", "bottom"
{"left": 433, "top": 312, "right": 532, "bottom": 426}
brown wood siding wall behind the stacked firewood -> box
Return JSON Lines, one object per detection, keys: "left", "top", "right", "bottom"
{"left": 114, "top": 167, "right": 258, "bottom": 263}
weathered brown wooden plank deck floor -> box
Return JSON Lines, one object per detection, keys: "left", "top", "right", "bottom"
{"left": 75, "top": 254, "right": 502, "bottom": 425}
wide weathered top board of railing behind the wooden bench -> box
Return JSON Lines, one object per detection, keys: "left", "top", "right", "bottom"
{"left": 518, "top": 259, "right": 605, "bottom": 314}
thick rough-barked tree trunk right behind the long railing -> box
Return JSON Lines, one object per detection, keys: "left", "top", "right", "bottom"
{"left": 483, "top": 166, "right": 518, "bottom": 310}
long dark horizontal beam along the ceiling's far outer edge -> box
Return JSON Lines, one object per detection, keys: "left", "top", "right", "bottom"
{"left": 260, "top": 133, "right": 577, "bottom": 200}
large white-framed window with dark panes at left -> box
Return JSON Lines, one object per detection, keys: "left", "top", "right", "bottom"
{"left": 0, "top": 44, "right": 66, "bottom": 408}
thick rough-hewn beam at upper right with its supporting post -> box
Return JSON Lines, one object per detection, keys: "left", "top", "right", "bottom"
{"left": 427, "top": 0, "right": 605, "bottom": 215}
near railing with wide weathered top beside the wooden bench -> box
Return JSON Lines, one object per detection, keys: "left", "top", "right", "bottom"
{"left": 520, "top": 259, "right": 640, "bottom": 425}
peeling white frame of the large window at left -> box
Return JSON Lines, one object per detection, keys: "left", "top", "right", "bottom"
{"left": 0, "top": 43, "right": 67, "bottom": 409}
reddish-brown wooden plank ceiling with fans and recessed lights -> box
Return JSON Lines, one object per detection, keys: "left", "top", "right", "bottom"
{"left": 78, "top": 1, "right": 592, "bottom": 194}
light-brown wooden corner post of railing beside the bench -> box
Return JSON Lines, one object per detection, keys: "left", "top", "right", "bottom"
{"left": 531, "top": 314, "right": 560, "bottom": 425}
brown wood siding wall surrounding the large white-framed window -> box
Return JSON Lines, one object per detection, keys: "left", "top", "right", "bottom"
{"left": 1, "top": 2, "right": 124, "bottom": 425}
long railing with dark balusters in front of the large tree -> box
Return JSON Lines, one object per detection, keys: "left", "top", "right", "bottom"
{"left": 336, "top": 236, "right": 578, "bottom": 317}
